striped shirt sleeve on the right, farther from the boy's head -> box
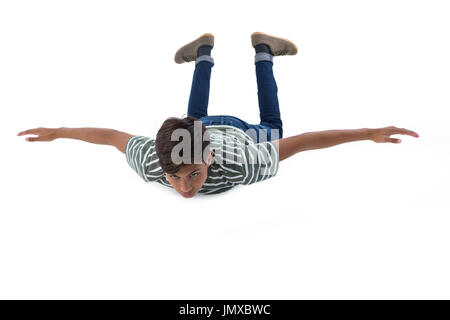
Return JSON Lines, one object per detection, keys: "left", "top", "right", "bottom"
{"left": 242, "top": 141, "right": 280, "bottom": 184}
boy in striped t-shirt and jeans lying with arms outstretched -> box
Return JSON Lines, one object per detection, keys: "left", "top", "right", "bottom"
{"left": 18, "top": 32, "right": 419, "bottom": 198}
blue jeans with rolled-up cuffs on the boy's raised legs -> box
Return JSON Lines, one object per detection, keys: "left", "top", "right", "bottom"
{"left": 188, "top": 53, "right": 283, "bottom": 142}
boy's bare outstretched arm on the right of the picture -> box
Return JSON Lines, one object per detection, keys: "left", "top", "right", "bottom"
{"left": 274, "top": 126, "right": 419, "bottom": 161}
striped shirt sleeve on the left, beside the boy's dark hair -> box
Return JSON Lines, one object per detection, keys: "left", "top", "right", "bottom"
{"left": 125, "top": 136, "right": 164, "bottom": 182}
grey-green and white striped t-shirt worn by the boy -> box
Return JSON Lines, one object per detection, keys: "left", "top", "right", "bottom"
{"left": 125, "top": 125, "right": 279, "bottom": 194}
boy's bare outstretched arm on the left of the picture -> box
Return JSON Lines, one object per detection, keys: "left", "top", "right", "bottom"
{"left": 17, "top": 127, "right": 132, "bottom": 153}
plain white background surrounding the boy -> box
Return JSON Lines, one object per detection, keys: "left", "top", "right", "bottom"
{"left": 0, "top": 0, "right": 450, "bottom": 299}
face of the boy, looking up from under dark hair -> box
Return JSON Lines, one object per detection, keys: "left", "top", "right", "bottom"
{"left": 166, "top": 152, "right": 212, "bottom": 198}
